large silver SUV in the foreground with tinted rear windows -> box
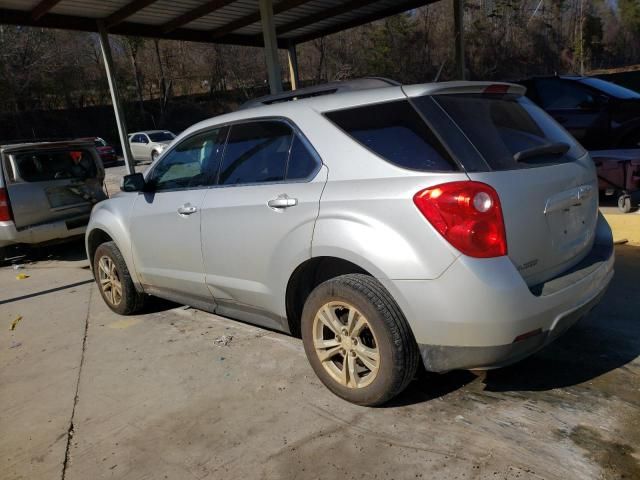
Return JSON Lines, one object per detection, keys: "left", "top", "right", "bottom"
{"left": 86, "top": 82, "right": 614, "bottom": 405}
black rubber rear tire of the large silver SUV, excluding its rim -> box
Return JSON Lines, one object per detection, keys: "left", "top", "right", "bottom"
{"left": 301, "top": 274, "right": 420, "bottom": 407}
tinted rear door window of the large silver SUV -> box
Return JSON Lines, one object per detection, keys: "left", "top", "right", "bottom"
{"left": 218, "top": 121, "right": 293, "bottom": 185}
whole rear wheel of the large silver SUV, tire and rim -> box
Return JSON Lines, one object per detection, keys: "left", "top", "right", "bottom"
{"left": 301, "top": 274, "right": 420, "bottom": 407}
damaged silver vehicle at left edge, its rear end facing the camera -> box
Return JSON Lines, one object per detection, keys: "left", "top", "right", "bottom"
{"left": 0, "top": 141, "right": 106, "bottom": 262}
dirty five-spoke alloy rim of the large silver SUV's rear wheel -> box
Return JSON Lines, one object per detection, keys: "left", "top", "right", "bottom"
{"left": 313, "top": 302, "right": 380, "bottom": 388}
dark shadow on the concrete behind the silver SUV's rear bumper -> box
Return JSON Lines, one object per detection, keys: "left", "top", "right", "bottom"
{"left": 390, "top": 245, "right": 640, "bottom": 406}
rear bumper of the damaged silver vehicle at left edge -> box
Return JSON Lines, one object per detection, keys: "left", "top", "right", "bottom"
{"left": 0, "top": 215, "right": 89, "bottom": 248}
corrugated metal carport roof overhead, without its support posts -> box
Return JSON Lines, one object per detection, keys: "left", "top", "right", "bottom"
{"left": 0, "top": 0, "right": 437, "bottom": 48}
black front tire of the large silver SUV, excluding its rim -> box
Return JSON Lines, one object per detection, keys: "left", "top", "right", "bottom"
{"left": 93, "top": 242, "right": 145, "bottom": 315}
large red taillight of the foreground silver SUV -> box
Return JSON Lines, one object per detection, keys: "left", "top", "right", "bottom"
{"left": 413, "top": 181, "right": 507, "bottom": 258}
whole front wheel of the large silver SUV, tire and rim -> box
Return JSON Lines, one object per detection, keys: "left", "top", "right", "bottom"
{"left": 93, "top": 242, "right": 145, "bottom": 315}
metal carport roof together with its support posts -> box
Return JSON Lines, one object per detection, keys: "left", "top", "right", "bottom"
{"left": 0, "top": 0, "right": 464, "bottom": 173}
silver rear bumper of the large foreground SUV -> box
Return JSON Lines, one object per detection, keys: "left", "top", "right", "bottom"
{"left": 382, "top": 218, "right": 614, "bottom": 372}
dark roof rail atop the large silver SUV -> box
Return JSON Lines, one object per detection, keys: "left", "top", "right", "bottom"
{"left": 239, "top": 77, "right": 401, "bottom": 110}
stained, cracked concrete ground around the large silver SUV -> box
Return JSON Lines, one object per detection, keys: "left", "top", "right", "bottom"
{"left": 0, "top": 167, "right": 640, "bottom": 480}
